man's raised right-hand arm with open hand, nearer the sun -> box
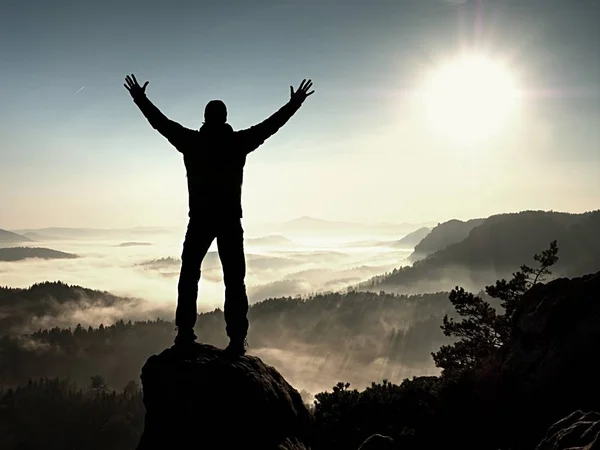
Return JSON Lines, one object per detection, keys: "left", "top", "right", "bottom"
{"left": 238, "top": 80, "right": 315, "bottom": 153}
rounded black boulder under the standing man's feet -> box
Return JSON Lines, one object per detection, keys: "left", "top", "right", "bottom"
{"left": 137, "top": 344, "right": 311, "bottom": 450}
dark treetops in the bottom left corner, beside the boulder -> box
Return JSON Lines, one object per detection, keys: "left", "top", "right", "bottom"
{"left": 0, "top": 376, "right": 145, "bottom": 450}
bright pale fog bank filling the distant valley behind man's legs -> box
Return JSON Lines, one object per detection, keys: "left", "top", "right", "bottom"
{"left": 0, "top": 216, "right": 422, "bottom": 314}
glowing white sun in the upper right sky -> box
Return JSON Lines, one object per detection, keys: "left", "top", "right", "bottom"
{"left": 422, "top": 56, "right": 521, "bottom": 143}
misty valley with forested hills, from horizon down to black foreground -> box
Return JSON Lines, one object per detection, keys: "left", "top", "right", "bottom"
{"left": 0, "top": 211, "right": 600, "bottom": 395}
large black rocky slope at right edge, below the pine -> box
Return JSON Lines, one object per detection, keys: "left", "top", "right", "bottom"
{"left": 474, "top": 272, "right": 600, "bottom": 449}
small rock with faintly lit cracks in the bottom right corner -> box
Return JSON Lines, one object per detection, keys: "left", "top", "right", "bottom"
{"left": 536, "top": 411, "right": 600, "bottom": 450}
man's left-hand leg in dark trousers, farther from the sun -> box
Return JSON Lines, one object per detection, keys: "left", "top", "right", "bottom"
{"left": 175, "top": 219, "right": 215, "bottom": 344}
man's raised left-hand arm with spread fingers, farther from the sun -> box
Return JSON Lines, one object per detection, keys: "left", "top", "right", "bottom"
{"left": 124, "top": 74, "right": 193, "bottom": 151}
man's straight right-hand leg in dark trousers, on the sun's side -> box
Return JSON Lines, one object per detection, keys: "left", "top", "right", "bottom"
{"left": 217, "top": 218, "right": 249, "bottom": 353}
